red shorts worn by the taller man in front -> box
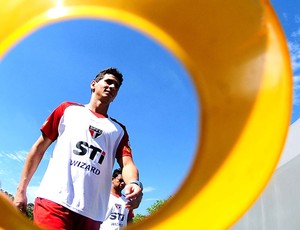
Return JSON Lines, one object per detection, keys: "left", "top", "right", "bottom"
{"left": 33, "top": 197, "right": 101, "bottom": 230}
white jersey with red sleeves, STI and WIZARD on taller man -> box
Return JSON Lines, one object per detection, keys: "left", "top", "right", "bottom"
{"left": 37, "top": 102, "right": 131, "bottom": 221}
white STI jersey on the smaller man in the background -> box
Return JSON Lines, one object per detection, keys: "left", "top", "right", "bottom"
{"left": 100, "top": 194, "right": 133, "bottom": 230}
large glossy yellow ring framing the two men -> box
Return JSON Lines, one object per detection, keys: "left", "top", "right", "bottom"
{"left": 0, "top": 0, "right": 292, "bottom": 229}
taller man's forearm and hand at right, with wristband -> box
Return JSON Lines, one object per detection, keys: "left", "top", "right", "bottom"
{"left": 119, "top": 156, "right": 143, "bottom": 209}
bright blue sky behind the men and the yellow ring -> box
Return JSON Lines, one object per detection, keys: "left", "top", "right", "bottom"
{"left": 0, "top": 0, "right": 300, "bottom": 214}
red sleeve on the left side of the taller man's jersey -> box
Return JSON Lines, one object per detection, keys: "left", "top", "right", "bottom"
{"left": 40, "top": 102, "right": 75, "bottom": 141}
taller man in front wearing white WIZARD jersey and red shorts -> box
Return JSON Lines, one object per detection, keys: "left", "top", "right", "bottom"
{"left": 14, "top": 68, "right": 142, "bottom": 230}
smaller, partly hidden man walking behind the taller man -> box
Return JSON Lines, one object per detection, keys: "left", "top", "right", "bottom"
{"left": 100, "top": 169, "right": 138, "bottom": 230}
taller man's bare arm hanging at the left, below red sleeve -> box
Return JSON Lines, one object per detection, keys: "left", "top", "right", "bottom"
{"left": 14, "top": 134, "right": 52, "bottom": 212}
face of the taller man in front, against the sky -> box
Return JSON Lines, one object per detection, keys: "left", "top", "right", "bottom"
{"left": 91, "top": 74, "right": 120, "bottom": 102}
